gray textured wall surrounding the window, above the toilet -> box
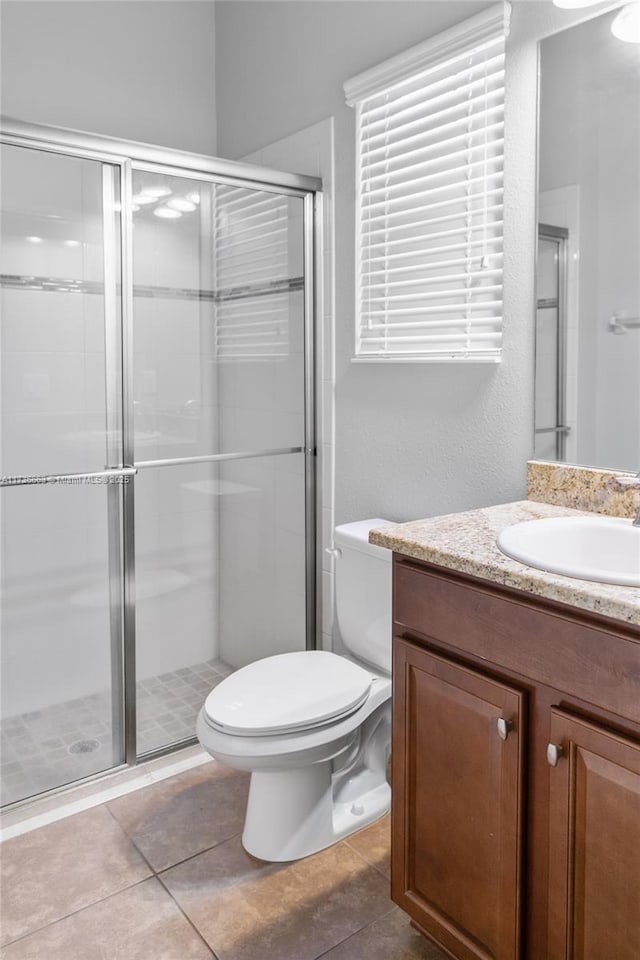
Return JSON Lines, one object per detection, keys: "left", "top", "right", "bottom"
{"left": 216, "top": 0, "right": 535, "bottom": 523}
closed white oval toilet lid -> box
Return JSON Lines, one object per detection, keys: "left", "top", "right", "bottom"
{"left": 204, "top": 650, "right": 372, "bottom": 737}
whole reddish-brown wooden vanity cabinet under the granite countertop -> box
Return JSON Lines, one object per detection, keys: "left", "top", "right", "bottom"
{"left": 392, "top": 555, "right": 640, "bottom": 960}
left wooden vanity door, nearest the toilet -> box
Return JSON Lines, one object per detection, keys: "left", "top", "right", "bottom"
{"left": 392, "top": 640, "right": 524, "bottom": 960}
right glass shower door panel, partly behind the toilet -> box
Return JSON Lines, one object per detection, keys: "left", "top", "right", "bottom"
{"left": 133, "top": 171, "right": 312, "bottom": 754}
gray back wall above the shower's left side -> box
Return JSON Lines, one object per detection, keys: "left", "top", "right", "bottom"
{"left": 0, "top": 0, "right": 216, "bottom": 154}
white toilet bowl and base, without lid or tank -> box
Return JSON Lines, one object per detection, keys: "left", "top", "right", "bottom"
{"left": 197, "top": 677, "right": 391, "bottom": 863}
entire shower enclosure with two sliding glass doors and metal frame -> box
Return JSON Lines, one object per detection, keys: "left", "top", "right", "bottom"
{"left": 0, "top": 122, "right": 320, "bottom": 804}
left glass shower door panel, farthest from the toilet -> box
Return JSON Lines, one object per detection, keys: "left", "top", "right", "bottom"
{"left": 0, "top": 145, "right": 126, "bottom": 804}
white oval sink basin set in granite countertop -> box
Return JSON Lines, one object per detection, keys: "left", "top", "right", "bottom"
{"left": 498, "top": 517, "right": 640, "bottom": 587}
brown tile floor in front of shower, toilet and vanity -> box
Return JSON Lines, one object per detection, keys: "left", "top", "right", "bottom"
{"left": 0, "top": 761, "right": 444, "bottom": 960}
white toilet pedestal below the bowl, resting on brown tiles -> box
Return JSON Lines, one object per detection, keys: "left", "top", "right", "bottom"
{"left": 242, "top": 760, "right": 391, "bottom": 863}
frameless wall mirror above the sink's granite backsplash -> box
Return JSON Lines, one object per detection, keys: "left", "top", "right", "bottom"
{"left": 534, "top": 11, "right": 640, "bottom": 471}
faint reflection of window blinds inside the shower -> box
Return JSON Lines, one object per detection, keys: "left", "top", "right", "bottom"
{"left": 214, "top": 186, "right": 291, "bottom": 360}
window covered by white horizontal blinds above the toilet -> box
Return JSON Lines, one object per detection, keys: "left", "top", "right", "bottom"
{"left": 345, "top": 3, "right": 509, "bottom": 361}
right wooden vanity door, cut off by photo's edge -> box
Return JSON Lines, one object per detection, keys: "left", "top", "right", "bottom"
{"left": 548, "top": 710, "right": 640, "bottom": 960}
